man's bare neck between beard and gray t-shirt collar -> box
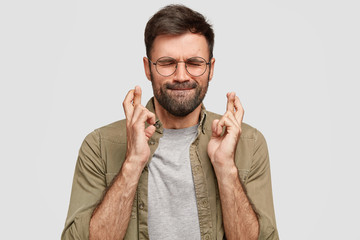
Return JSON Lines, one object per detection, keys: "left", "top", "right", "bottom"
{"left": 154, "top": 98, "right": 202, "bottom": 129}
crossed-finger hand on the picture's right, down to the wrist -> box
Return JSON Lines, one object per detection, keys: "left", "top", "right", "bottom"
{"left": 207, "top": 92, "right": 244, "bottom": 178}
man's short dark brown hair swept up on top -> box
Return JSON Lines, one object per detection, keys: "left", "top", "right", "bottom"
{"left": 144, "top": 4, "right": 214, "bottom": 60}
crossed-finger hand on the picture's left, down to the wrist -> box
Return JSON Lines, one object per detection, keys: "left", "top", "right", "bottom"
{"left": 123, "top": 86, "right": 156, "bottom": 168}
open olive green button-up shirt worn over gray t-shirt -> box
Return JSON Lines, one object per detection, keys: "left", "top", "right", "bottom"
{"left": 61, "top": 99, "right": 279, "bottom": 240}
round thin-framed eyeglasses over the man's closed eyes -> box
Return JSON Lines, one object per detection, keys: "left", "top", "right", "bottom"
{"left": 149, "top": 57, "right": 210, "bottom": 77}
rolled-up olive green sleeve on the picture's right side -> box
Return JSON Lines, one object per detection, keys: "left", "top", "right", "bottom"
{"left": 246, "top": 130, "right": 279, "bottom": 240}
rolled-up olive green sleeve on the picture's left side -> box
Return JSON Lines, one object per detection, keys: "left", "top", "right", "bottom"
{"left": 61, "top": 130, "right": 106, "bottom": 240}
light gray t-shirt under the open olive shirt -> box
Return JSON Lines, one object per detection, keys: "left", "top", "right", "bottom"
{"left": 148, "top": 125, "right": 201, "bottom": 240}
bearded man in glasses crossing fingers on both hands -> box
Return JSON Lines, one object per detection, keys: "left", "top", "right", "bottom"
{"left": 62, "top": 5, "right": 278, "bottom": 240}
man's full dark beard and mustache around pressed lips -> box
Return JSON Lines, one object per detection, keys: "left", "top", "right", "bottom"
{"left": 151, "top": 74, "right": 209, "bottom": 117}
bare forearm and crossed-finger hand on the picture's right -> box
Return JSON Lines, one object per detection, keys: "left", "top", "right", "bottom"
{"left": 208, "top": 92, "right": 259, "bottom": 239}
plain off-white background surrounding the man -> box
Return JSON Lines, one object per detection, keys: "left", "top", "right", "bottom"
{"left": 0, "top": 0, "right": 360, "bottom": 240}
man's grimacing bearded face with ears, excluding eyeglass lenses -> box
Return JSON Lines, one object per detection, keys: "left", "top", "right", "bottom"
{"left": 144, "top": 32, "right": 215, "bottom": 116}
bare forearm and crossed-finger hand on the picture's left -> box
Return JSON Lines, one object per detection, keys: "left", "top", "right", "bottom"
{"left": 89, "top": 87, "right": 155, "bottom": 240}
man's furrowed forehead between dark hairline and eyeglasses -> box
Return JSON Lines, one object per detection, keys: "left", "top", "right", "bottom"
{"left": 151, "top": 32, "right": 209, "bottom": 60}
